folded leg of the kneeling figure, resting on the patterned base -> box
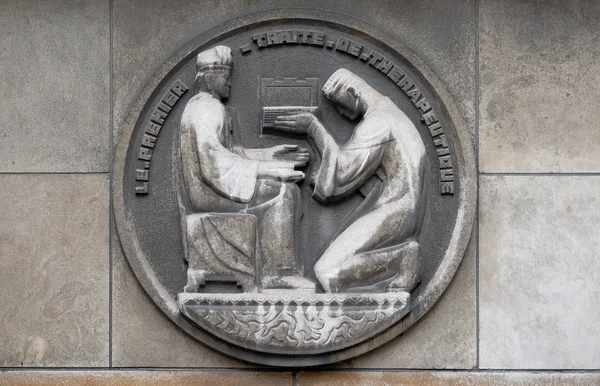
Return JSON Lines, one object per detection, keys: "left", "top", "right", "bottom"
{"left": 315, "top": 200, "right": 421, "bottom": 292}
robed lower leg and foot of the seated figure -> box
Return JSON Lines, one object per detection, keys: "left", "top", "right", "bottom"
{"left": 244, "top": 180, "right": 315, "bottom": 290}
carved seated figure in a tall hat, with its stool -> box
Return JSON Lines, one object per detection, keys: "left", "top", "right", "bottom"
{"left": 179, "top": 46, "right": 314, "bottom": 292}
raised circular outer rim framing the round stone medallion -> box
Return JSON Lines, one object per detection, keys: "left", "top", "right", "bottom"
{"left": 114, "top": 10, "right": 474, "bottom": 365}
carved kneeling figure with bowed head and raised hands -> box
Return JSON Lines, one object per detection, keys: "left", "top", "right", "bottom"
{"left": 275, "top": 69, "right": 427, "bottom": 292}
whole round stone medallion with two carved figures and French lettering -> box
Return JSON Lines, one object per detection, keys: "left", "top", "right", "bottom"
{"left": 114, "top": 10, "right": 475, "bottom": 366}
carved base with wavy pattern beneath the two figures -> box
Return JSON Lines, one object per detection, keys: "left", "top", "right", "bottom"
{"left": 178, "top": 292, "right": 410, "bottom": 354}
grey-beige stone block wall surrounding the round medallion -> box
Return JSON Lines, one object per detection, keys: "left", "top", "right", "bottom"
{"left": 0, "top": 0, "right": 600, "bottom": 385}
